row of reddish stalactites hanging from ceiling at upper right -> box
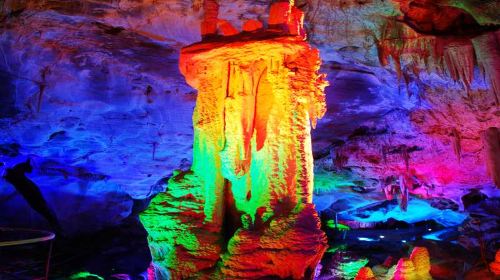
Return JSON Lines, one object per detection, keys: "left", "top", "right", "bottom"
{"left": 375, "top": 19, "right": 500, "bottom": 98}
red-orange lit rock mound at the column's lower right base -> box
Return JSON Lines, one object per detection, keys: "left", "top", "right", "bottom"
{"left": 221, "top": 204, "right": 327, "bottom": 279}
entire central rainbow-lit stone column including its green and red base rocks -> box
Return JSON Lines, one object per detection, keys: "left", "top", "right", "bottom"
{"left": 141, "top": 3, "right": 327, "bottom": 279}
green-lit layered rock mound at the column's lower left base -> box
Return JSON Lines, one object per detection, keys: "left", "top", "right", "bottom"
{"left": 140, "top": 171, "right": 223, "bottom": 279}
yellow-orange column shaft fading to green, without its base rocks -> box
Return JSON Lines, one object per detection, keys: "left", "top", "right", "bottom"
{"left": 180, "top": 37, "right": 326, "bottom": 228}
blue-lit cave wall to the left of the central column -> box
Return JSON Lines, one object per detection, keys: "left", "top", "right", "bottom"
{"left": 0, "top": 10, "right": 196, "bottom": 234}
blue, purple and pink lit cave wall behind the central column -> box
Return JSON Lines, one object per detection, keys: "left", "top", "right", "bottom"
{"left": 0, "top": 0, "right": 500, "bottom": 234}
